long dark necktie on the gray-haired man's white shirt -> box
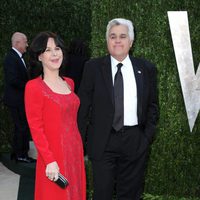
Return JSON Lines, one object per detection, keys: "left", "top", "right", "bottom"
{"left": 113, "top": 63, "right": 124, "bottom": 131}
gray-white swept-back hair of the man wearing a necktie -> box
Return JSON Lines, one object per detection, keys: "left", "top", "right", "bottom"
{"left": 106, "top": 18, "right": 134, "bottom": 41}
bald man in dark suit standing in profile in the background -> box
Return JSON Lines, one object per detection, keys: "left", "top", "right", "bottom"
{"left": 4, "top": 32, "right": 34, "bottom": 163}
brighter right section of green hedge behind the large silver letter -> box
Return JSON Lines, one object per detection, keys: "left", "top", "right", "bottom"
{"left": 91, "top": 0, "right": 200, "bottom": 197}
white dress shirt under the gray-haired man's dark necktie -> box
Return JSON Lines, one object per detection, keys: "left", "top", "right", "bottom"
{"left": 111, "top": 56, "right": 138, "bottom": 126}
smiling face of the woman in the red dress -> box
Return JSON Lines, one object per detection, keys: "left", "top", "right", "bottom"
{"left": 38, "top": 38, "right": 63, "bottom": 72}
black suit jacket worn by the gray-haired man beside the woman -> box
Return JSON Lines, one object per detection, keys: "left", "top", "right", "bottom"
{"left": 78, "top": 55, "right": 158, "bottom": 159}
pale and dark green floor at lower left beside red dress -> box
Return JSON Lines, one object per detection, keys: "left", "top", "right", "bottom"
{"left": 0, "top": 143, "right": 37, "bottom": 200}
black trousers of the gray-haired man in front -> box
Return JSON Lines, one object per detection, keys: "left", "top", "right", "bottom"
{"left": 91, "top": 126, "right": 149, "bottom": 200}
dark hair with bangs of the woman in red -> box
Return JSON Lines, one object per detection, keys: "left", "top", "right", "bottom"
{"left": 28, "top": 31, "right": 66, "bottom": 79}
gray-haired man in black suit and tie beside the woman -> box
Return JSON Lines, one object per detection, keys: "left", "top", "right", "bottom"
{"left": 78, "top": 18, "right": 158, "bottom": 200}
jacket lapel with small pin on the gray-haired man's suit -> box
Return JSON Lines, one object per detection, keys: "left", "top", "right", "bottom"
{"left": 130, "top": 57, "right": 144, "bottom": 120}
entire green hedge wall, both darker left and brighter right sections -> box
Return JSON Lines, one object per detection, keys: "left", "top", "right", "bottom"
{"left": 0, "top": 0, "right": 200, "bottom": 200}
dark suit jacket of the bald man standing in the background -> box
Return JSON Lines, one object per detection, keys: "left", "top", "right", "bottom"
{"left": 4, "top": 49, "right": 28, "bottom": 107}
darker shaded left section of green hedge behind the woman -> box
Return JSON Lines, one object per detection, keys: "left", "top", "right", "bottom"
{"left": 0, "top": 0, "right": 91, "bottom": 151}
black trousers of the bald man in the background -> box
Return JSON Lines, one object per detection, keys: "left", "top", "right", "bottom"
{"left": 9, "top": 105, "right": 30, "bottom": 157}
